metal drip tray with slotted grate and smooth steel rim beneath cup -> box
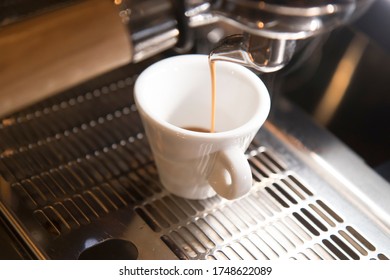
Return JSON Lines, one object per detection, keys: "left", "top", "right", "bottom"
{"left": 0, "top": 63, "right": 390, "bottom": 259}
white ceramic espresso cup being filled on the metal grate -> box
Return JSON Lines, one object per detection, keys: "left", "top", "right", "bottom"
{"left": 134, "top": 55, "right": 270, "bottom": 199}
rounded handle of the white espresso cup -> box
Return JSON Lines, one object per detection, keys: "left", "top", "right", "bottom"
{"left": 208, "top": 147, "right": 252, "bottom": 199}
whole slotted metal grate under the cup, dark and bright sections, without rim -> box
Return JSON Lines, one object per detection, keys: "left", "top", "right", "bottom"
{"left": 0, "top": 64, "right": 387, "bottom": 259}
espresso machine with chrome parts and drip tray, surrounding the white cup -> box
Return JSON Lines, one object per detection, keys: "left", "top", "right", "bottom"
{"left": 0, "top": 0, "right": 390, "bottom": 260}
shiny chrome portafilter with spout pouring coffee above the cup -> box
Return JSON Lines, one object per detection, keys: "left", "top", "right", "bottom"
{"left": 187, "top": 0, "right": 373, "bottom": 73}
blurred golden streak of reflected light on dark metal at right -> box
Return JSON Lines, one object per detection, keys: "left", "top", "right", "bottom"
{"left": 314, "top": 35, "right": 369, "bottom": 125}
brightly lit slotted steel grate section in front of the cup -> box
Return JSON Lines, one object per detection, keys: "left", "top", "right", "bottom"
{"left": 137, "top": 171, "right": 379, "bottom": 259}
